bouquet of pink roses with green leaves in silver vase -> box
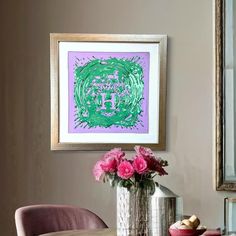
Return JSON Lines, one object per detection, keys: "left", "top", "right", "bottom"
{"left": 93, "top": 146, "right": 168, "bottom": 194}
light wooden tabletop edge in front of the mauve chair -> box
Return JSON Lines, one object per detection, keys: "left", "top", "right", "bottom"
{"left": 39, "top": 229, "right": 116, "bottom": 236}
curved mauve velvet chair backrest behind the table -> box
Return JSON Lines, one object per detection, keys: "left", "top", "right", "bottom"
{"left": 15, "top": 205, "right": 107, "bottom": 236}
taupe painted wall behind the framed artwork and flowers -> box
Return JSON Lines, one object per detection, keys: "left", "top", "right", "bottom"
{"left": 0, "top": 0, "right": 232, "bottom": 236}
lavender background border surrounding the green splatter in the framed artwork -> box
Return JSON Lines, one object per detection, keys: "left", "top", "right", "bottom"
{"left": 68, "top": 51, "right": 150, "bottom": 134}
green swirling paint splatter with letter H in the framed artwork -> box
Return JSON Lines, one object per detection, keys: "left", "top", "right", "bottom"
{"left": 74, "top": 57, "right": 144, "bottom": 128}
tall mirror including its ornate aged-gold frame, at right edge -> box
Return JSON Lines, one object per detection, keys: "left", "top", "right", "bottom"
{"left": 215, "top": 0, "right": 236, "bottom": 191}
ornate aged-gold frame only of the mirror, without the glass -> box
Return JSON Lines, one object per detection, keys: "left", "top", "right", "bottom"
{"left": 215, "top": 0, "right": 236, "bottom": 191}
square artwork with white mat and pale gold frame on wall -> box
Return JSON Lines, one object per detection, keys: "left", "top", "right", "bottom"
{"left": 50, "top": 34, "right": 167, "bottom": 150}
